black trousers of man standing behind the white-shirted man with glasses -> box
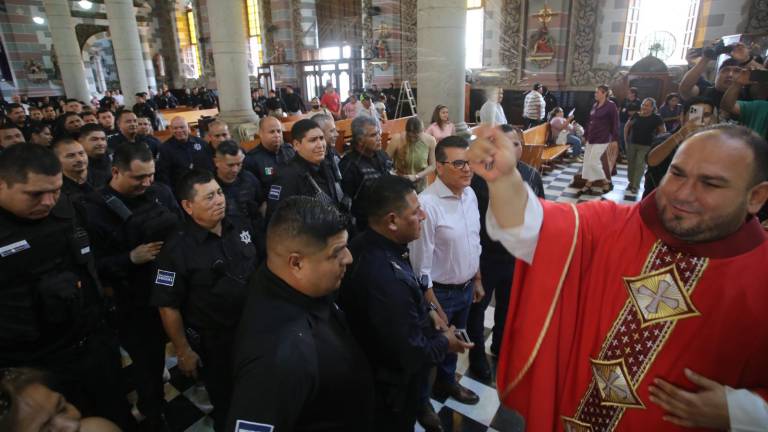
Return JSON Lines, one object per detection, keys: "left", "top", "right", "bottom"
{"left": 467, "top": 255, "right": 515, "bottom": 361}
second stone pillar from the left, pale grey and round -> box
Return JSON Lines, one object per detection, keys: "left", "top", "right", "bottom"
{"left": 104, "top": 0, "right": 148, "bottom": 107}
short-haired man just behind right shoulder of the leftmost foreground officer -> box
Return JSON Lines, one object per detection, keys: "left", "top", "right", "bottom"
{"left": 51, "top": 138, "right": 94, "bottom": 203}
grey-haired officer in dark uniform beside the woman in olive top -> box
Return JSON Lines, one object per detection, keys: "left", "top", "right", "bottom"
{"left": 339, "top": 116, "right": 393, "bottom": 231}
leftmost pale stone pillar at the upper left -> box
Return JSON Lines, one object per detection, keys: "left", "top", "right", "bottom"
{"left": 43, "top": 0, "right": 91, "bottom": 102}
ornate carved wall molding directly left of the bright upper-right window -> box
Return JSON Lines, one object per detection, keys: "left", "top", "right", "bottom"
{"left": 566, "top": 0, "right": 619, "bottom": 88}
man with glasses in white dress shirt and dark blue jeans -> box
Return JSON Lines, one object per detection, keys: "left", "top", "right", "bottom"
{"left": 409, "top": 136, "right": 484, "bottom": 404}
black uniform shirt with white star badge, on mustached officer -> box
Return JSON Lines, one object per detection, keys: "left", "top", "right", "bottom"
{"left": 151, "top": 216, "right": 258, "bottom": 330}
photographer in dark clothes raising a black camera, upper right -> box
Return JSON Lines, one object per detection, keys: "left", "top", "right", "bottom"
{"left": 680, "top": 40, "right": 752, "bottom": 107}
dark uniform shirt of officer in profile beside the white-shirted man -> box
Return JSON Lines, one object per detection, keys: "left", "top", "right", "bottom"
{"left": 339, "top": 229, "right": 448, "bottom": 391}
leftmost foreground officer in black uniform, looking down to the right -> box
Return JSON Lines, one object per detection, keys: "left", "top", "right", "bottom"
{"left": 0, "top": 144, "right": 135, "bottom": 430}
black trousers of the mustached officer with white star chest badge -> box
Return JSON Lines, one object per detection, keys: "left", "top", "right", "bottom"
{"left": 197, "top": 327, "right": 236, "bottom": 432}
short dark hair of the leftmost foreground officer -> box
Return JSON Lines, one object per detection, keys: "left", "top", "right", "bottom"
{"left": 0, "top": 144, "right": 61, "bottom": 186}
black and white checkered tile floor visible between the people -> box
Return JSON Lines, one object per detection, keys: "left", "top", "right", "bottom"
{"left": 120, "top": 162, "right": 642, "bottom": 432}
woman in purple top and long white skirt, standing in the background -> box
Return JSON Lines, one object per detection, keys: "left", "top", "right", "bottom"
{"left": 581, "top": 85, "right": 619, "bottom": 193}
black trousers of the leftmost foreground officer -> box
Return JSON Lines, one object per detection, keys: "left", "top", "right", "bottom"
{"left": 35, "top": 326, "right": 136, "bottom": 431}
